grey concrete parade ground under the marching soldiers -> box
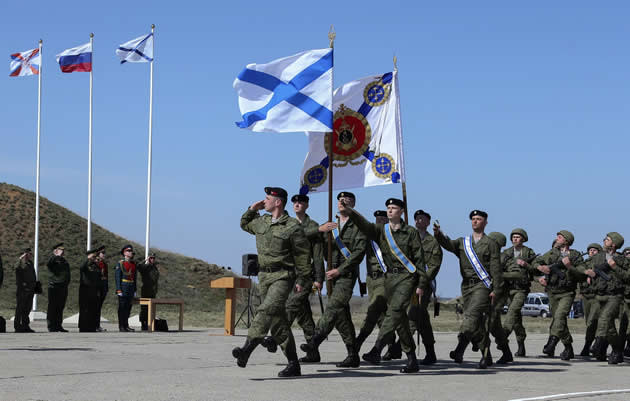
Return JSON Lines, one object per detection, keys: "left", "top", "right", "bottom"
{"left": 0, "top": 322, "right": 630, "bottom": 400}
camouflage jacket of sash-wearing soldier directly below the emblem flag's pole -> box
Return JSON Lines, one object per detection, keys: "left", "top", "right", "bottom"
{"left": 350, "top": 209, "right": 430, "bottom": 288}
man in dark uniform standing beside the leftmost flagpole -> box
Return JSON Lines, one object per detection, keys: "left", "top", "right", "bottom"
{"left": 13, "top": 248, "right": 37, "bottom": 333}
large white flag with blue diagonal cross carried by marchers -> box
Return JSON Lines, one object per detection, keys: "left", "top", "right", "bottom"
{"left": 233, "top": 49, "right": 333, "bottom": 132}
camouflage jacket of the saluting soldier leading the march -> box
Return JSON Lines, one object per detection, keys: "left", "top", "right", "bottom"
{"left": 241, "top": 208, "right": 311, "bottom": 286}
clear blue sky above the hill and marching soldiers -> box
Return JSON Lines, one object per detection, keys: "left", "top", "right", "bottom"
{"left": 0, "top": 1, "right": 630, "bottom": 296}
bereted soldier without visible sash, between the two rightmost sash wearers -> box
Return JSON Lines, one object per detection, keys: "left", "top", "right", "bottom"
{"left": 408, "top": 210, "right": 443, "bottom": 365}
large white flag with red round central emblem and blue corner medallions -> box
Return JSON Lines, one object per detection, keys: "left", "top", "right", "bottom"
{"left": 300, "top": 71, "right": 405, "bottom": 194}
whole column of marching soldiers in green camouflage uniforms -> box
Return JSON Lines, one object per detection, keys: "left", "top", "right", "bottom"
{"left": 232, "top": 187, "right": 630, "bottom": 377}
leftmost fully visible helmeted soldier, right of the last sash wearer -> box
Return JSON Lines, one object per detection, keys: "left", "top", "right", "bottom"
{"left": 501, "top": 228, "right": 536, "bottom": 356}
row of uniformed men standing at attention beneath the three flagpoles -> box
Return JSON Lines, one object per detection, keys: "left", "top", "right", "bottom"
{"left": 0, "top": 243, "right": 160, "bottom": 333}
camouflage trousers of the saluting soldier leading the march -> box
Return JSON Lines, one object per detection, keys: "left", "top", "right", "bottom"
{"left": 247, "top": 273, "right": 296, "bottom": 356}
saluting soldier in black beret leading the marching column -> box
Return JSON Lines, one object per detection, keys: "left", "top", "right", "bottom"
{"left": 232, "top": 187, "right": 312, "bottom": 377}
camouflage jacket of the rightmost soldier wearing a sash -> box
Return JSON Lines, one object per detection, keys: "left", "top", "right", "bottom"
{"left": 435, "top": 232, "right": 505, "bottom": 297}
